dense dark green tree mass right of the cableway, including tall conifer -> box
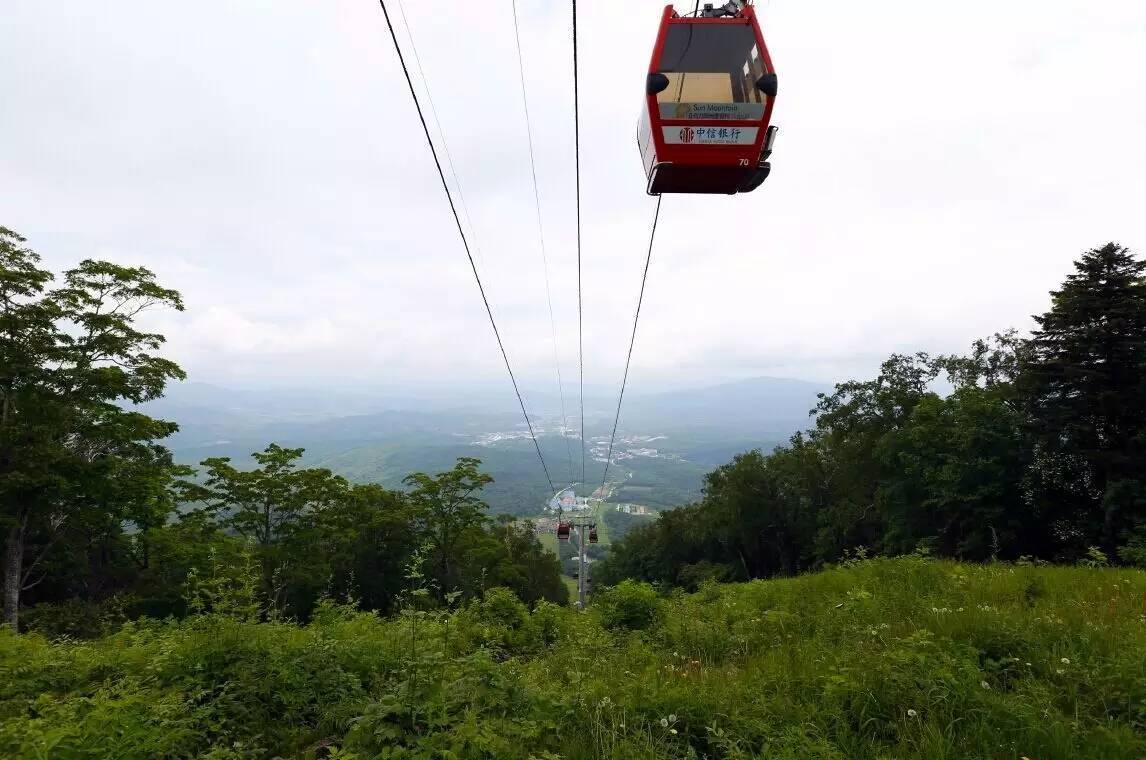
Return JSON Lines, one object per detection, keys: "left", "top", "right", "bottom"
{"left": 596, "top": 244, "right": 1146, "bottom": 588}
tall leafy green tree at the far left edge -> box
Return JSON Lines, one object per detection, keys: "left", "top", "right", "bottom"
{"left": 0, "top": 227, "right": 185, "bottom": 626}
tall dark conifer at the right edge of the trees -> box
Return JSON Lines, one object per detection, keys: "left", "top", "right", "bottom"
{"left": 1022, "top": 243, "right": 1146, "bottom": 549}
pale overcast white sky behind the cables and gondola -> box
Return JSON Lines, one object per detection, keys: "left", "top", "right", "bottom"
{"left": 0, "top": 0, "right": 1146, "bottom": 392}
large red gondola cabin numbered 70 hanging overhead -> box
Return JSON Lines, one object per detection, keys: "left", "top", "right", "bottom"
{"left": 637, "top": 0, "right": 776, "bottom": 195}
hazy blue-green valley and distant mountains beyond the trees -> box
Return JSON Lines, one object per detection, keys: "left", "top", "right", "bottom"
{"left": 147, "top": 377, "right": 830, "bottom": 514}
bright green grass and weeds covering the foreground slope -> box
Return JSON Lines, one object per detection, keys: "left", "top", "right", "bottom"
{"left": 0, "top": 558, "right": 1146, "bottom": 760}
